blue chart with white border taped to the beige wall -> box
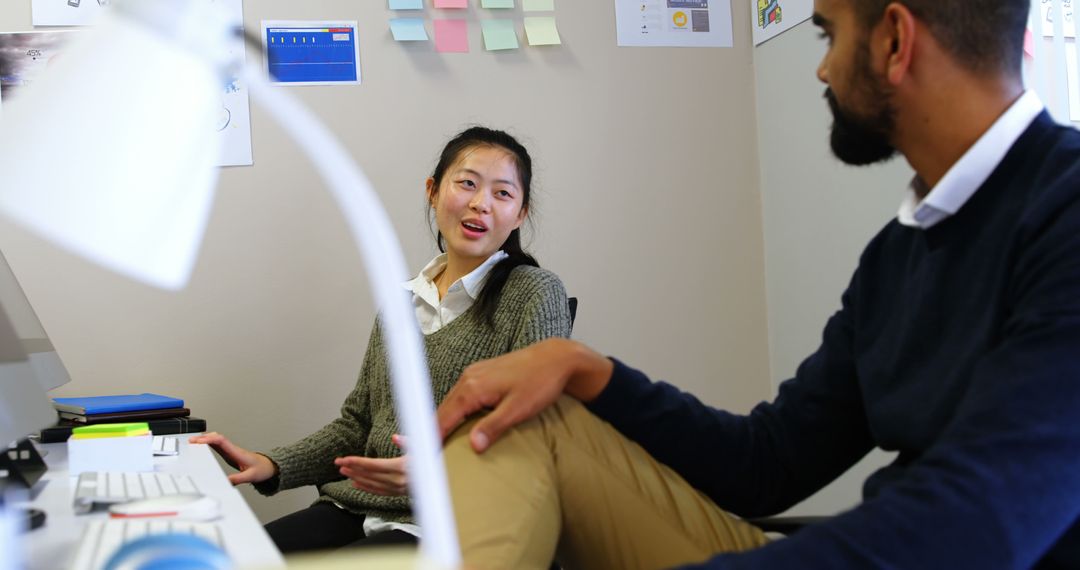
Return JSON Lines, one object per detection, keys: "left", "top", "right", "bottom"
{"left": 262, "top": 19, "right": 361, "bottom": 85}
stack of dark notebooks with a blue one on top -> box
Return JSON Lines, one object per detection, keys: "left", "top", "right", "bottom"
{"left": 40, "top": 394, "right": 206, "bottom": 444}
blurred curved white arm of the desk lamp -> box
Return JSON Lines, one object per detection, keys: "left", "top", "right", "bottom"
{"left": 243, "top": 66, "right": 461, "bottom": 568}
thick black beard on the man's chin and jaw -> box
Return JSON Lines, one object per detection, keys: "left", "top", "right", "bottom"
{"left": 825, "top": 84, "right": 896, "bottom": 166}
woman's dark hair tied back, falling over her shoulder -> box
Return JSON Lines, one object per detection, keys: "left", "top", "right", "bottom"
{"left": 428, "top": 126, "right": 540, "bottom": 327}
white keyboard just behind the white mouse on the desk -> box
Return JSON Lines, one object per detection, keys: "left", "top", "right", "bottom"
{"left": 73, "top": 471, "right": 201, "bottom": 513}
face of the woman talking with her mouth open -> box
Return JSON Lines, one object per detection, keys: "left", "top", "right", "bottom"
{"left": 428, "top": 146, "right": 526, "bottom": 266}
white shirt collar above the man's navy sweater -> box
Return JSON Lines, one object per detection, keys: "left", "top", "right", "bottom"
{"left": 896, "top": 91, "right": 1042, "bottom": 230}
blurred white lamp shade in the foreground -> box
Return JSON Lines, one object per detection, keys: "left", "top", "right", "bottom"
{"left": 0, "top": 16, "right": 221, "bottom": 289}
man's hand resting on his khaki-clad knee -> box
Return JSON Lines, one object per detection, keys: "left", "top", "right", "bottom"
{"left": 437, "top": 338, "right": 615, "bottom": 453}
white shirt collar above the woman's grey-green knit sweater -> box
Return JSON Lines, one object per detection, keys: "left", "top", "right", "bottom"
{"left": 405, "top": 249, "right": 510, "bottom": 335}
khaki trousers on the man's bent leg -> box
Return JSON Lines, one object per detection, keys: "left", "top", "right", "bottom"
{"left": 445, "top": 397, "right": 767, "bottom": 570}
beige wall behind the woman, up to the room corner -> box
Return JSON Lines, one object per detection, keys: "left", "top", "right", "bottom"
{"left": 0, "top": 0, "right": 777, "bottom": 520}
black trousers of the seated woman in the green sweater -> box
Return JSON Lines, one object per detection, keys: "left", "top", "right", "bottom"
{"left": 266, "top": 503, "right": 417, "bottom": 554}
